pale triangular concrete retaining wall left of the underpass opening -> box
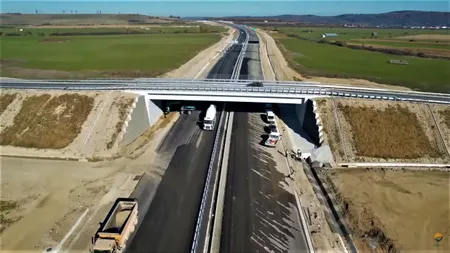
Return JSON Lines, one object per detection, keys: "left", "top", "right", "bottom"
{"left": 118, "top": 95, "right": 163, "bottom": 147}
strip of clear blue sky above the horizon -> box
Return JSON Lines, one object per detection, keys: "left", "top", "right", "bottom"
{"left": 0, "top": 0, "right": 450, "bottom": 17}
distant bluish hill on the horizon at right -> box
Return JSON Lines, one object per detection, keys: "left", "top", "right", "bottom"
{"left": 190, "top": 11, "right": 450, "bottom": 26}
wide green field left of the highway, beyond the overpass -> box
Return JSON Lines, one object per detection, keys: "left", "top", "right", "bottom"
{"left": 1, "top": 33, "right": 220, "bottom": 78}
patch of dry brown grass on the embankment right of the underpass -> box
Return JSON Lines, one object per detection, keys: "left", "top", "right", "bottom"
{"left": 338, "top": 103, "right": 441, "bottom": 159}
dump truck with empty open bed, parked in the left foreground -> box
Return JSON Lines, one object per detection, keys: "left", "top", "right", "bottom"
{"left": 91, "top": 198, "right": 138, "bottom": 253}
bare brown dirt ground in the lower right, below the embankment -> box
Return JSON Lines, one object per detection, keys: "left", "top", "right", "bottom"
{"left": 327, "top": 169, "right": 450, "bottom": 252}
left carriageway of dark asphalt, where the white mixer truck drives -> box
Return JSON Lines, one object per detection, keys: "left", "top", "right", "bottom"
{"left": 126, "top": 26, "right": 245, "bottom": 253}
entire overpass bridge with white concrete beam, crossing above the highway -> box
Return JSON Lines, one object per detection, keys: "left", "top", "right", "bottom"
{"left": 0, "top": 78, "right": 450, "bottom": 104}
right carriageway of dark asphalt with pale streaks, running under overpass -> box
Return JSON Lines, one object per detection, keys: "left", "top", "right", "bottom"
{"left": 220, "top": 27, "right": 307, "bottom": 253}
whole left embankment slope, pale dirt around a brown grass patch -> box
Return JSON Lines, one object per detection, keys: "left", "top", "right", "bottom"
{"left": 0, "top": 90, "right": 135, "bottom": 158}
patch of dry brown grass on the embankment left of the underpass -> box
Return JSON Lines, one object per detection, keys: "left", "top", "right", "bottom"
{"left": 0, "top": 94, "right": 94, "bottom": 149}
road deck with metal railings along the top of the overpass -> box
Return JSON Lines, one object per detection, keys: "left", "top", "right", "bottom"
{"left": 0, "top": 78, "right": 450, "bottom": 103}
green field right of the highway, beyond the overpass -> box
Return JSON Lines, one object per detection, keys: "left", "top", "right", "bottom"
{"left": 275, "top": 35, "right": 450, "bottom": 92}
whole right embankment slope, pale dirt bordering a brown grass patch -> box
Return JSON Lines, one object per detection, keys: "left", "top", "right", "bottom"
{"left": 319, "top": 99, "right": 450, "bottom": 163}
